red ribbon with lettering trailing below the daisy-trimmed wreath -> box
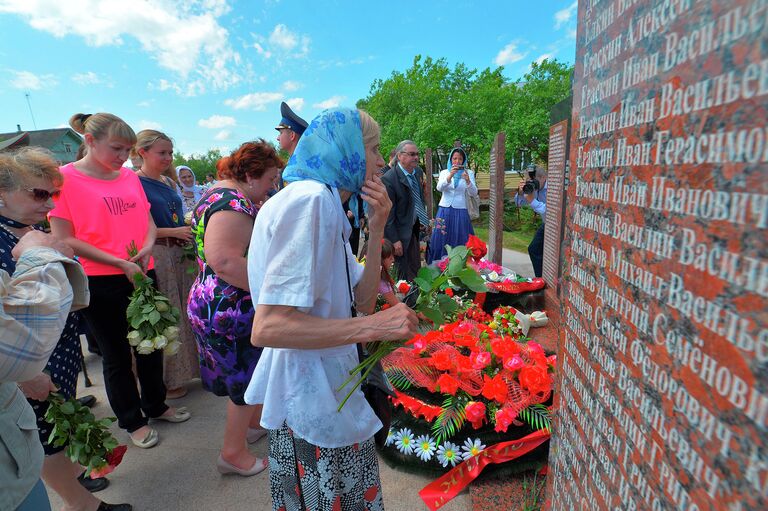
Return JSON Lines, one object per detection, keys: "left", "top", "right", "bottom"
{"left": 419, "top": 429, "right": 551, "bottom": 511}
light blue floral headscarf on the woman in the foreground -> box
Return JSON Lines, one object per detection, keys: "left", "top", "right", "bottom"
{"left": 283, "top": 108, "right": 367, "bottom": 225}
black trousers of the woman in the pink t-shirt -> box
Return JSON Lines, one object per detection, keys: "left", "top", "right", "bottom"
{"left": 83, "top": 271, "right": 168, "bottom": 433}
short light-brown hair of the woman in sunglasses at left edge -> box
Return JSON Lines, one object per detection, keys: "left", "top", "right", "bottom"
{"left": 0, "top": 147, "right": 64, "bottom": 195}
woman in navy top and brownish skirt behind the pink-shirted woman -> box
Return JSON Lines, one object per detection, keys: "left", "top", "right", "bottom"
{"left": 133, "top": 130, "right": 200, "bottom": 399}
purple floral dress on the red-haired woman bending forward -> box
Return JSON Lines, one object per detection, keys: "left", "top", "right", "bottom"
{"left": 187, "top": 188, "right": 261, "bottom": 405}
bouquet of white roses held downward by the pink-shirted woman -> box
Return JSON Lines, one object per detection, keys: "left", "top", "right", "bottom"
{"left": 126, "top": 242, "right": 181, "bottom": 355}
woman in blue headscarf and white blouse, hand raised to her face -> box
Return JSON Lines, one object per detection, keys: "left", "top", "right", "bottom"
{"left": 245, "top": 108, "right": 418, "bottom": 510}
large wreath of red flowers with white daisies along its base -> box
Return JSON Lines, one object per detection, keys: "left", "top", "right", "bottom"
{"left": 382, "top": 305, "right": 556, "bottom": 473}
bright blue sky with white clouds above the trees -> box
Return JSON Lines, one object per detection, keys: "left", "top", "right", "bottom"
{"left": 0, "top": 0, "right": 577, "bottom": 155}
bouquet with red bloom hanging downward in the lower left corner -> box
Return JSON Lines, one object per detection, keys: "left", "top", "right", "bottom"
{"left": 45, "top": 393, "right": 126, "bottom": 478}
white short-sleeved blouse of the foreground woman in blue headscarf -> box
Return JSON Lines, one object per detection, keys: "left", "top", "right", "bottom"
{"left": 245, "top": 181, "right": 382, "bottom": 448}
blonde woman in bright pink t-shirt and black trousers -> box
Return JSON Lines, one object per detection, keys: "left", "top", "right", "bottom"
{"left": 50, "top": 113, "right": 189, "bottom": 448}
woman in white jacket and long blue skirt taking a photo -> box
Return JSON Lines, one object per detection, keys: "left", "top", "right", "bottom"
{"left": 427, "top": 147, "right": 477, "bottom": 264}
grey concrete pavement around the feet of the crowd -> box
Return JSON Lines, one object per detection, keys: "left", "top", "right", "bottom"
{"left": 49, "top": 354, "right": 471, "bottom": 511}
